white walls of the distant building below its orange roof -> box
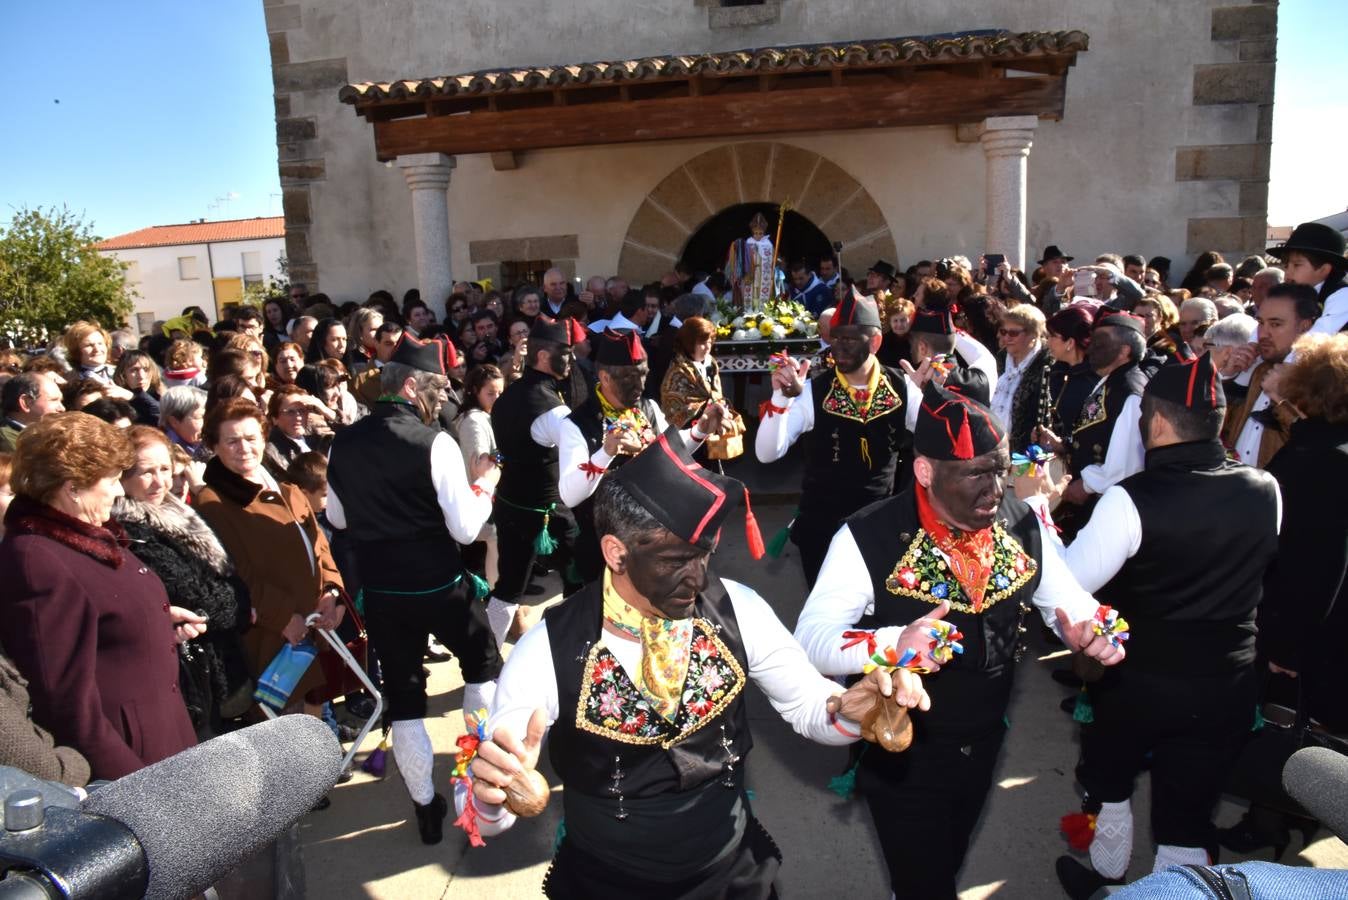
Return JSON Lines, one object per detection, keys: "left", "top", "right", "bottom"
{"left": 101, "top": 237, "right": 286, "bottom": 332}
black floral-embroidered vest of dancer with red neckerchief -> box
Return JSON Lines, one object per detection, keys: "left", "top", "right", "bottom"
{"left": 847, "top": 489, "right": 1042, "bottom": 757}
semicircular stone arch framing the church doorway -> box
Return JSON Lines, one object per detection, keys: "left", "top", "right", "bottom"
{"left": 617, "top": 141, "right": 899, "bottom": 284}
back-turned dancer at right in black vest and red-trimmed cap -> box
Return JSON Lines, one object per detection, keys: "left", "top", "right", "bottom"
{"left": 1024, "top": 354, "right": 1281, "bottom": 897}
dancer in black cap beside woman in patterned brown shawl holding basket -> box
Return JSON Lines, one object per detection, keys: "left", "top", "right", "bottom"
{"left": 557, "top": 329, "right": 725, "bottom": 582}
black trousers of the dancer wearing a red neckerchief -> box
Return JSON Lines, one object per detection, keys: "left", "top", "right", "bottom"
{"left": 857, "top": 725, "right": 1006, "bottom": 900}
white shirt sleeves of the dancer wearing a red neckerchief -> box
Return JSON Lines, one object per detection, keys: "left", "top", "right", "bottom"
{"left": 795, "top": 516, "right": 1100, "bottom": 678}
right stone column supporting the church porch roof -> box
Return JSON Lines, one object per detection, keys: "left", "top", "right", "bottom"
{"left": 979, "top": 116, "right": 1039, "bottom": 272}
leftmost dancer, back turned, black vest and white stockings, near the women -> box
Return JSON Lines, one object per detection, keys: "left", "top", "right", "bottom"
{"left": 328, "top": 333, "right": 501, "bottom": 843}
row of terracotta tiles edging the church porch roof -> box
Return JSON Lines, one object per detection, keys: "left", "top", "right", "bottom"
{"left": 337, "top": 31, "right": 1091, "bottom": 105}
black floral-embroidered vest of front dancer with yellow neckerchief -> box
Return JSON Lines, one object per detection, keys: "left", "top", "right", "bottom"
{"left": 543, "top": 575, "right": 754, "bottom": 806}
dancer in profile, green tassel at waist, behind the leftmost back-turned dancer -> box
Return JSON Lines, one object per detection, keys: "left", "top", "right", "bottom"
{"left": 488, "top": 318, "right": 581, "bottom": 643}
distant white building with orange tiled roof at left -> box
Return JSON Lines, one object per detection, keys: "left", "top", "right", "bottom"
{"left": 97, "top": 216, "right": 286, "bottom": 334}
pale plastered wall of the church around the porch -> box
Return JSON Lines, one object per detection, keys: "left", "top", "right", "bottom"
{"left": 286, "top": 0, "right": 1258, "bottom": 299}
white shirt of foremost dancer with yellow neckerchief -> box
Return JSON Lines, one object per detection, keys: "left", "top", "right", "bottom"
{"left": 456, "top": 579, "right": 860, "bottom": 837}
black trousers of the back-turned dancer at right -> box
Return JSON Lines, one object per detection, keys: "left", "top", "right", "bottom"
{"left": 1077, "top": 663, "right": 1258, "bottom": 851}
